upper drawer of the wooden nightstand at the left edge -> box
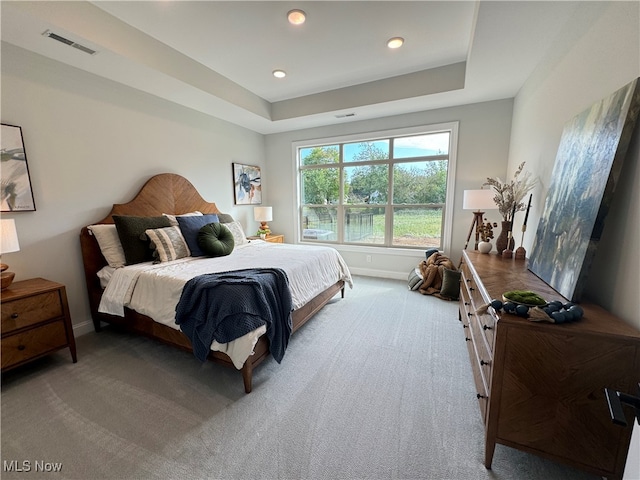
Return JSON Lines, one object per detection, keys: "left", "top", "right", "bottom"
{"left": 2, "top": 290, "right": 64, "bottom": 334}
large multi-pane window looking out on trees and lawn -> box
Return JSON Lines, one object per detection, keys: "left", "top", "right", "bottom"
{"left": 294, "top": 123, "right": 457, "bottom": 249}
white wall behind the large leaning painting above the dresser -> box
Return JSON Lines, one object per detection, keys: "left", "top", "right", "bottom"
{"left": 509, "top": 2, "right": 640, "bottom": 328}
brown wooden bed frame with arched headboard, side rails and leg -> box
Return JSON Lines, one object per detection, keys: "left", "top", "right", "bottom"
{"left": 80, "top": 173, "right": 344, "bottom": 393}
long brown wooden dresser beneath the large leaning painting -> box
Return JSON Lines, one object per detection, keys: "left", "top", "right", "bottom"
{"left": 459, "top": 251, "right": 640, "bottom": 478}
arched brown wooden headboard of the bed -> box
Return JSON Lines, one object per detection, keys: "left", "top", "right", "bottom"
{"left": 80, "top": 173, "right": 222, "bottom": 319}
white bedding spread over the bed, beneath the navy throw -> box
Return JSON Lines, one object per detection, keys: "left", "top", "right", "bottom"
{"left": 98, "top": 240, "right": 353, "bottom": 369}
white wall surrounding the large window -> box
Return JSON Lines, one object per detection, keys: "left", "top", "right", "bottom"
{"left": 266, "top": 99, "right": 513, "bottom": 279}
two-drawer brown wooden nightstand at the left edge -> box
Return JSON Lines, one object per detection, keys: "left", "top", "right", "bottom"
{"left": 0, "top": 278, "right": 77, "bottom": 372}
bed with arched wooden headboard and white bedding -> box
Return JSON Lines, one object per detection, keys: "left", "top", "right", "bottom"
{"left": 80, "top": 173, "right": 352, "bottom": 393}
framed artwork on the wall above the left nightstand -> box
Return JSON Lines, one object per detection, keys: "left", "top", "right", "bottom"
{"left": 0, "top": 123, "right": 36, "bottom": 212}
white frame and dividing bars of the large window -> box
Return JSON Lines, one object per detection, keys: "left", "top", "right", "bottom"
{"left": 291, "top": 121, "right": 459, "bottom": 252}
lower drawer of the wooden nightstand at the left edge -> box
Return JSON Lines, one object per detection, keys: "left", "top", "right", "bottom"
{"left": 2, "top": 320, "right": 67, "bottom": 370}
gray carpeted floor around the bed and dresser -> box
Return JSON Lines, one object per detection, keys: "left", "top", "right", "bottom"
{"left": 1, "top": 277, "right": 596, "bottom": 480}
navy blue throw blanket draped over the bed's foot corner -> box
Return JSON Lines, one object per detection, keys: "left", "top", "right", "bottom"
{"left": 176, "top": 268, "right": 292, "bottom": 363}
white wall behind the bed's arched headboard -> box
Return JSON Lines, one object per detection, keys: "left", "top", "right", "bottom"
{"left": 2, "top": 43, "right": 268, "bottom": 333}
